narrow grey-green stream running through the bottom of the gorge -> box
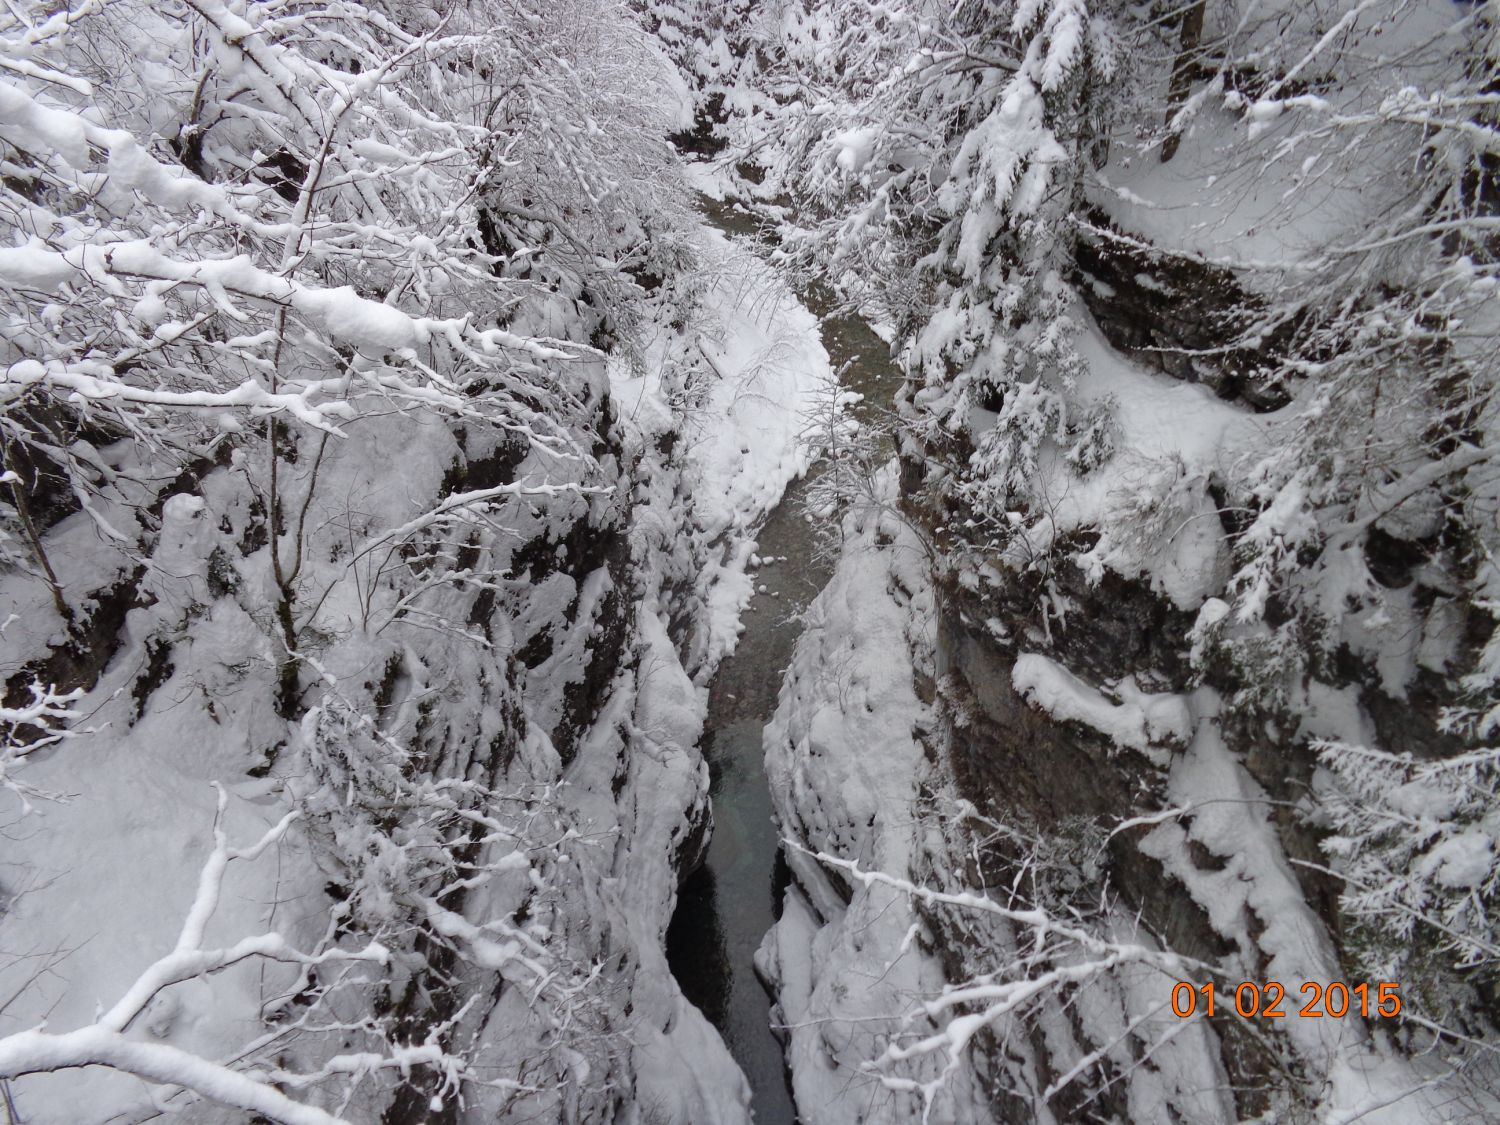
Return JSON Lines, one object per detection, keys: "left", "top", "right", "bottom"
{"left": 668, "top": 201, "right": 900, "bottom": 1125}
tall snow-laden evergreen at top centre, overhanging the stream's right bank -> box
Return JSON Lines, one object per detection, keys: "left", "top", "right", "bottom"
{"left": 720, "top": 3, "right": 1119, "bottom": 594}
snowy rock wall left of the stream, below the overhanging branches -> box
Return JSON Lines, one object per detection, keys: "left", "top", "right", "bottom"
{"left": 5, "top": 369, "right": 747, "bottom": 1125}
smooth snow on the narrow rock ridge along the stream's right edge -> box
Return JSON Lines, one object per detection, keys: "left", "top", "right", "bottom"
{"left": 758, "top": 471, "right": 989, "bottom": 1125}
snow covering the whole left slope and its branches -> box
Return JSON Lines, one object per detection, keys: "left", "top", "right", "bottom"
{"left": 0, "top": 0, "right": 786, "bottom": 1125}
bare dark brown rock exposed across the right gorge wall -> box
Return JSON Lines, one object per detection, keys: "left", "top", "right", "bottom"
{"left": 903, "top": 215, "right": 1487, "bottom": 1121}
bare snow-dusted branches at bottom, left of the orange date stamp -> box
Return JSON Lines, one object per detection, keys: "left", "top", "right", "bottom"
{"left": 815, "top": 824, "right": 1217, "bottom": 1125}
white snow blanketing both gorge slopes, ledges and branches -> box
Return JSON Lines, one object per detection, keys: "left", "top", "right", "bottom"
{"left": 0, "top": 0, "right": 1500, "bottom": 1125}
